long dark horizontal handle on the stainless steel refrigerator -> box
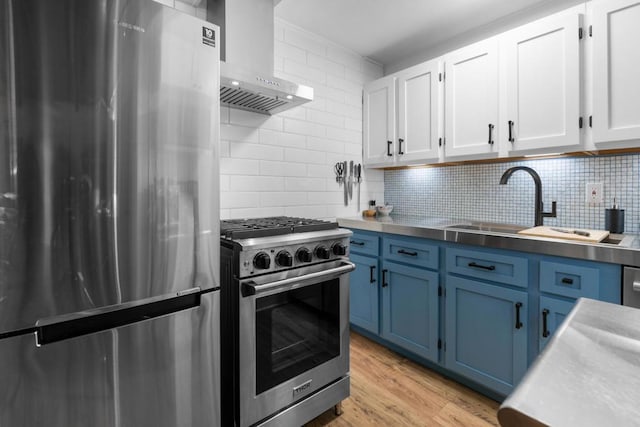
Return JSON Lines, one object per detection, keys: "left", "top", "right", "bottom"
{"left": 35, "top": 287, "right": 205, "bottom": 347}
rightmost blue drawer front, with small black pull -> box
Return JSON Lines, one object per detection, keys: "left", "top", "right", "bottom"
{"left": 540, "top": 261, "right": 600, "bottom": 299}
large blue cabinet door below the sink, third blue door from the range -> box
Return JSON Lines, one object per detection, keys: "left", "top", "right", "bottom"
{"left": 445, "top": 276, "right": 529, "bottom": 395}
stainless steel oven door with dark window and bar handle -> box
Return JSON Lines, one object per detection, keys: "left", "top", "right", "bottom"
{"left": 239, "top": 260, "right": 355, "bottom": 426}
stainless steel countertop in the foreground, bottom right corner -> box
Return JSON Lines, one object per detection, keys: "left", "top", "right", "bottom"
{"left": 498, "top": 298, "right": 640, "bottom": 427}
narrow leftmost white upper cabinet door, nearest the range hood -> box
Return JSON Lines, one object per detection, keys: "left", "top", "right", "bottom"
{"left": 362, "top": 77, "right": 396, "bottom": 166}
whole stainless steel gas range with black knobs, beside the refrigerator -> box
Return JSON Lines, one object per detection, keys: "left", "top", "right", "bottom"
{"left": 220, "top": 217, "right": 355, "bottom": 427}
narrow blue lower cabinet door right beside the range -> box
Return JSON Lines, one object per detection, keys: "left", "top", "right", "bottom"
{"left": 349, "top": 253, "right": 380, "bottom": 334}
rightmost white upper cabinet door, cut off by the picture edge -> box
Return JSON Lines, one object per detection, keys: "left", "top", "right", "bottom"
{"left": 593, "top": 0, "right": 640, "bottom": 147}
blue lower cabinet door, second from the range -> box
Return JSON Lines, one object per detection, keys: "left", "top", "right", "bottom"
{"left": 380, "top": 261, "right": 439, "bottom": 362}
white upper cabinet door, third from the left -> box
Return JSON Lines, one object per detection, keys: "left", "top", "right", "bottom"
{"left": 444, "top": 38, "right": 498, "bottom": 157}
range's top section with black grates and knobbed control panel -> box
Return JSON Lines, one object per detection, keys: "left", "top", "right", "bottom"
{"left": 220, "top": 217, "right": 351, "bottom": 278}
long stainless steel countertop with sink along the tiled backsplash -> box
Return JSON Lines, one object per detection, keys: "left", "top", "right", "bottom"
{"left": 337, "top": 215, "right": 640, "bottom": 267}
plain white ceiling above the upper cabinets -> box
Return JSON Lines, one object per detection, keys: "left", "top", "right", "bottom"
{"left": 275, "top": 0, "right": 581, "bottom": 70}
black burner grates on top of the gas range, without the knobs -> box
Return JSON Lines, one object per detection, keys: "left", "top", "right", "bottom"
{"left": 220, "top": 216, "right": 338, "bottom": 240}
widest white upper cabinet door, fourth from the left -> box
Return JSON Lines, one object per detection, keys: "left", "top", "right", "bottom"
{"left": 500, "top": 12, "right": 582, "bottom": 152}
